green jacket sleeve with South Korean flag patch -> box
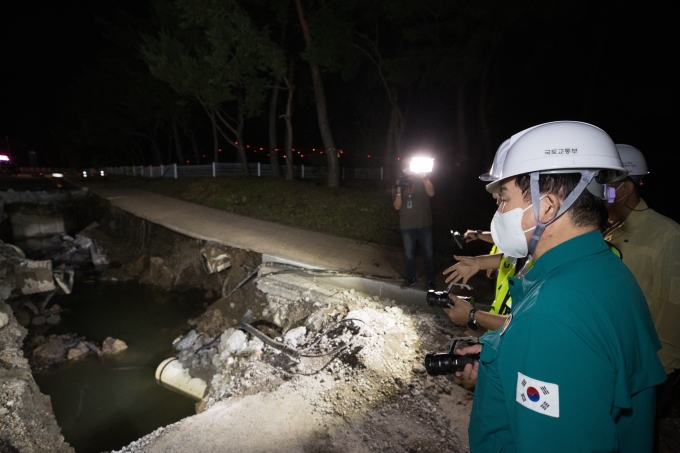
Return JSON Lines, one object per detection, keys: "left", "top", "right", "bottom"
{"left": 500, "top": 314, "right": 621, "bottom": 453}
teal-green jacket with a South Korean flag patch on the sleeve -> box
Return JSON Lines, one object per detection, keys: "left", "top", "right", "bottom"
{"left": 469, "top": 231, "right": 666, "bottom": 453}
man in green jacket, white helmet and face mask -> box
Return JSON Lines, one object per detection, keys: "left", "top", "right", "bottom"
{"left": 458, "top": 121, "right": 666, "bottom": 453}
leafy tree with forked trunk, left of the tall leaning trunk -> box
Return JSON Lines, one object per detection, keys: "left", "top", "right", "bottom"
{"left": 141, "top": 0, "right": 285, "bottom": 175}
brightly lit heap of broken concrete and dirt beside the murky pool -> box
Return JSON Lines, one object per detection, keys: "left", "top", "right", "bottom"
{"left": 114, "top": 267, "right": 472, "bottom": 452}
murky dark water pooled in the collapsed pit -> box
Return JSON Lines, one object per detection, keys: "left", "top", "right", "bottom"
{"left": 34, "top": 281, "right": 204, "bottom": 453}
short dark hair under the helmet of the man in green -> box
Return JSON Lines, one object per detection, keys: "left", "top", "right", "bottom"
{"left": 515, "top": 173, "right": 608, "bottom": 229}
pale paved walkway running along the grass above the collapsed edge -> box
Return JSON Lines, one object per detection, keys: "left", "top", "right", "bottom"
{"left": 88, "top": 184, "right": 403, "bottom": 279}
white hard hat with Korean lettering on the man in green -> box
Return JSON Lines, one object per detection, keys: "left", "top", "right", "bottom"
{"left": 486, "top": 121, "right": 627, "bottom": 193}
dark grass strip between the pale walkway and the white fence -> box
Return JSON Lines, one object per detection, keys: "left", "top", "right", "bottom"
{"left": 111, "top": 176, "right": 401, "bottom": 246}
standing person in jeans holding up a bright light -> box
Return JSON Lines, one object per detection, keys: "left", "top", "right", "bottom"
{"left": 392, "top": 158, "right": 435, "bottom": 289}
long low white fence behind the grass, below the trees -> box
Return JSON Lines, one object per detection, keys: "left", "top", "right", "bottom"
{"left": 104, "top": 163, "right": 384, "bottom": 180}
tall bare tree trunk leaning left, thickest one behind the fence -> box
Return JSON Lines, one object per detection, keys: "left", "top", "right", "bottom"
{"left": 295, "top": 0, "right": 340, "bottom": 187}
